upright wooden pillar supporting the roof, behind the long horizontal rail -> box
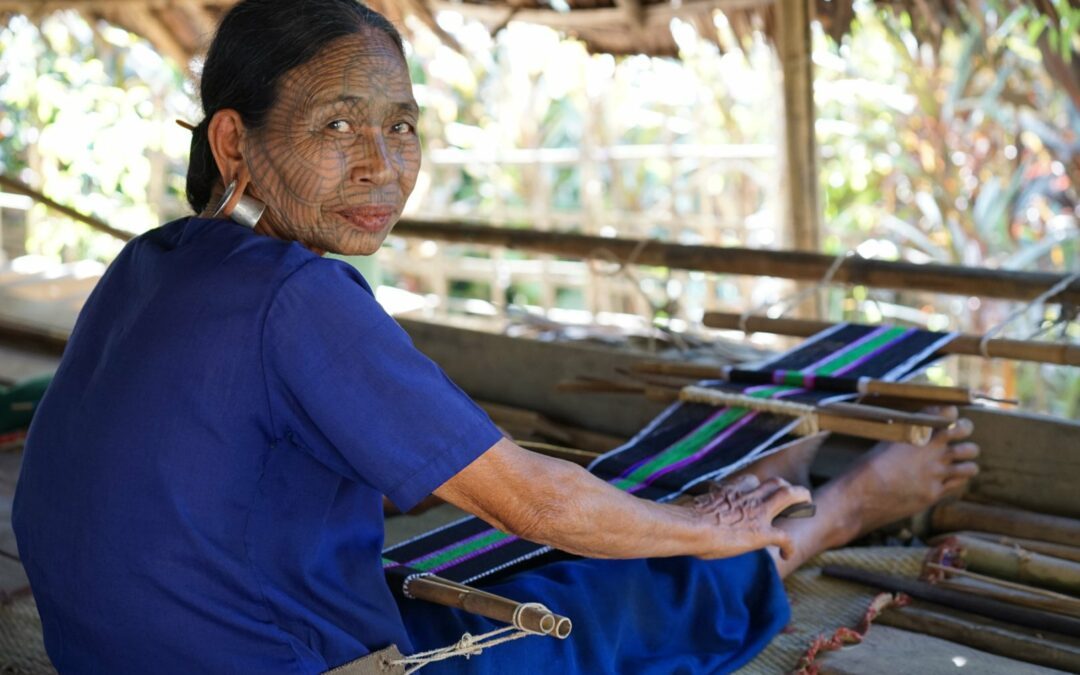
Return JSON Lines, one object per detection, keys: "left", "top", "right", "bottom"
{"left": 777, "top": 0, "right": 821, "bottom": 253}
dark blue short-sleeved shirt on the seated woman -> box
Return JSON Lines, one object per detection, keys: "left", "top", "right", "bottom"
{"left": 13, "top": 218, "right": 500, "bottom": 674}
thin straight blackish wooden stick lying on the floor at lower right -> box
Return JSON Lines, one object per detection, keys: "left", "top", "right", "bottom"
{"left": 822, "top": 565, "right": 1080, "bottom": 637}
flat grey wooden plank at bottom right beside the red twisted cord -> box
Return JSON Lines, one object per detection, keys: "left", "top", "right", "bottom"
{"left": 818, "top": 612, "right": 1061, "bottom": 675}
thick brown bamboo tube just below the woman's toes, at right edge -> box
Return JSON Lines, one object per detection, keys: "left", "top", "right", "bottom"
{"left": 930, "top": 500, "right": 1080, "bottom": 546}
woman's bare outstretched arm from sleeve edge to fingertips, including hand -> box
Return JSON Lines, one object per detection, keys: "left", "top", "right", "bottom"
{"left": 435, "top": 438, "right": 810, "bottom": 558}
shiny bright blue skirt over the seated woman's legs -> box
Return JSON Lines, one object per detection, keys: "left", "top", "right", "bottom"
{"left": 399, "top": 551, "right": 791, "bottom": 675}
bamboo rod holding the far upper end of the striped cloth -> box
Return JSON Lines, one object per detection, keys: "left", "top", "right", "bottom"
{"left": 702, "top": 313, "right": 1080, "bottom": 366}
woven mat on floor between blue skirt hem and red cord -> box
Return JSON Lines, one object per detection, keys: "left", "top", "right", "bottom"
{"left": 738, "top": 546, "right": 927, "bottom": 675}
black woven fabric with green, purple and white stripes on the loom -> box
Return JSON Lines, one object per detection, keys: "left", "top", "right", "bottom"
{"left": 383, "top": 324, "right": 953, "bottom": 583}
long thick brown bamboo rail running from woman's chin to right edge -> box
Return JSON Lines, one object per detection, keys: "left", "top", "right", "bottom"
{"left": 394, "top": 218, "right": 1080, "bottom": 302}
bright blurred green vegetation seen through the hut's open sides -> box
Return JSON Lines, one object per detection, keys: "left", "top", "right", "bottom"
{"left": 0, "top": 0, "right": 1080, "bottom": 418}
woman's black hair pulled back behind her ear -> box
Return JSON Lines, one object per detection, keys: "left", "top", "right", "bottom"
{"left": 187, "top": 0, "right": 405, "bottom": 213}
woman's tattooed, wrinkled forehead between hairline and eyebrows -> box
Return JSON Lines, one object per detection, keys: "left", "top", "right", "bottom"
{"left": 279, "top": 29, "right": 413, "bottom": 106}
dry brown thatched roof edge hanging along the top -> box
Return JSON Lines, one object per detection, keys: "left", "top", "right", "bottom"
{"left": 0, "top": 0, "right": 1071, "bottom": 63}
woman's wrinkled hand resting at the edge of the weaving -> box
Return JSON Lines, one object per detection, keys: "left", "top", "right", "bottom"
{"left": 683, "top": 474, "right": 810, "bottom": 559}
